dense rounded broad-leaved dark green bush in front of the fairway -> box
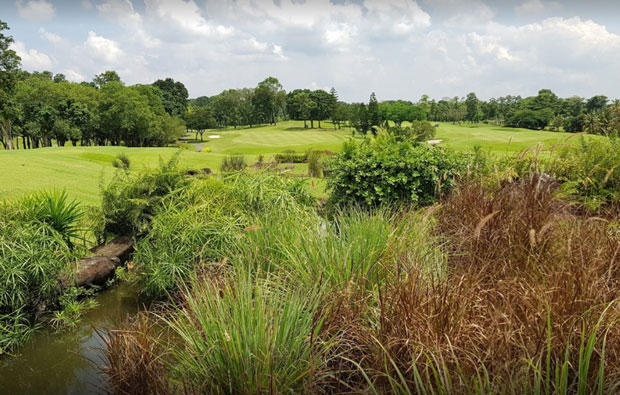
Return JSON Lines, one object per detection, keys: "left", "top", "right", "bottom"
{"left": 327, "top": 136, "right": 465, "bottom": 207}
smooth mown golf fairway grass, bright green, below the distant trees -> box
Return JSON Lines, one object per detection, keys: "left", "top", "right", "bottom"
{"left": 0, "top": 121, "right": 592, "bottom": 204}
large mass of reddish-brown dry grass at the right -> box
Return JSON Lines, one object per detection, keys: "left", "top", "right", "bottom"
{"left": 364, "top": 176, "right": 620, "bottom": 391}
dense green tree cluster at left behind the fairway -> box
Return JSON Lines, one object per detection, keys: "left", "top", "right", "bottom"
{"left": 0, "top": 21, "right": 188, "bottom": 149}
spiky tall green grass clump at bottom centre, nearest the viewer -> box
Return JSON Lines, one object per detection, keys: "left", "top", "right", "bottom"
{"left": 165, "top": 273, "right": 322, "bottom": 394}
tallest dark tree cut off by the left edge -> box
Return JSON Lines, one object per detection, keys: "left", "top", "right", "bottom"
{"left": 0, "top": 20, "right": 21, "bottom": 150}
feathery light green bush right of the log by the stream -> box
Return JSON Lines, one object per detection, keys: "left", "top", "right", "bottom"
{"left": 134, "top": 173, "right": 313, "bottom": 296}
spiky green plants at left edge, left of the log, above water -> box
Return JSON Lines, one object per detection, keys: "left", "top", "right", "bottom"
{"left": 0, "top": 192, "right": 83, "bottom": 354}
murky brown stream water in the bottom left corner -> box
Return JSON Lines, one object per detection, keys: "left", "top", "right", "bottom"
{"left": 0, "top": 284, "right": 140, "bottom": 395}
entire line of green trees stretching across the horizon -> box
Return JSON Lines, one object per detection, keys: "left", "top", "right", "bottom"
{"left": 0, "top": 21, "right": 620, "bottom": 149}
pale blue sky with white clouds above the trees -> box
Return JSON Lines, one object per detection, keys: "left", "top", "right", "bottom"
{"left": 0, "top": 0, "right": 620, "bottom": 101}
